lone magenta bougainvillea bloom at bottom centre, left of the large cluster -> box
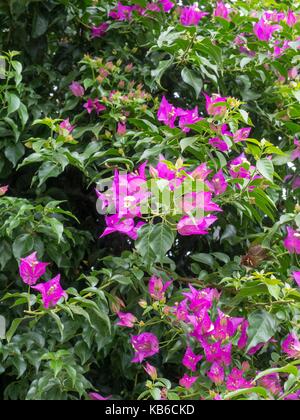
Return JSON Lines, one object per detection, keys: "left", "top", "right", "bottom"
{"left": 131, "top": 333, "right": 159, "bottom": 363}
